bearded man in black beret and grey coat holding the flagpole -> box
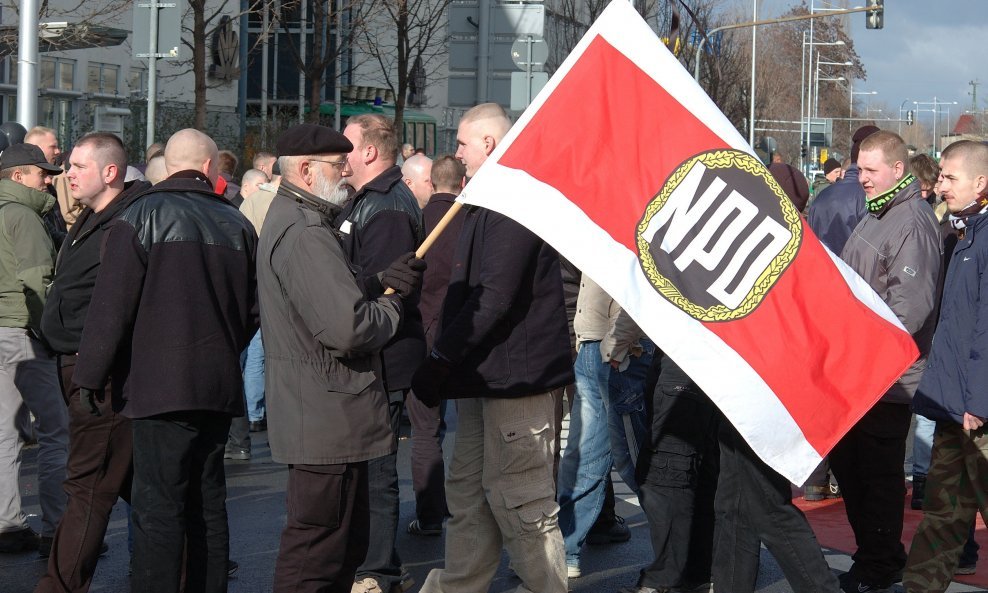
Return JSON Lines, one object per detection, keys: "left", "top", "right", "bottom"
{"left": 258, "top": 124, "right": 424, "bottom": 593}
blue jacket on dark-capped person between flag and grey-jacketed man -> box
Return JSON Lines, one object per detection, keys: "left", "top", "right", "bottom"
{"left": 809, "top": 165, "right": 866, "bottom": 255}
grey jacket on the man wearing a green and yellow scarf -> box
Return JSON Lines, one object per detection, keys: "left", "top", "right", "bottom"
{"left": 841, "top": 181, "right": 943, "bottom": 404}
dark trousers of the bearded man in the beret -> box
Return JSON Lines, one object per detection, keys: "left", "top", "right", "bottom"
{"left": 273, "top": 462, "right": 370, "bottom": 593}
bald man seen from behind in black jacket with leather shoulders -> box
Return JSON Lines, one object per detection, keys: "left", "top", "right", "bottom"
{"left": 73, "top": 129, "right": 257, "bottom": 593}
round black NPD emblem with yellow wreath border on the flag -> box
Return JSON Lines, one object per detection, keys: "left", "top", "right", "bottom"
{"left": 636, "top": 150, "right": 803, "bottom": 321}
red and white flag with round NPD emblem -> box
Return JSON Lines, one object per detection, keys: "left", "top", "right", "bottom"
{"left": 460, "top": 0, "right": 917, "bottom": 484}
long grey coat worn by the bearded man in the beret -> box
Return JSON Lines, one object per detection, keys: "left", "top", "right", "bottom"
{"left": 257, "top": 180, "right": 401, "bottom": 465}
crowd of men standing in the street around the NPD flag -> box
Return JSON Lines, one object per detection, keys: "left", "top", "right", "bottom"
{"left": 0, "top": 104, "right": 988, "bottom": 593}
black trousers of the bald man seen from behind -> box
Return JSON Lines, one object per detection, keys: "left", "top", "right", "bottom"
{"left": 131, "top": 412, "right": 230, "bottom": 593}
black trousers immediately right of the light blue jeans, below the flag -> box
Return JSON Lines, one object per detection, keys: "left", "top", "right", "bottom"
{"left": 638, "top": 383, "right": 719, "bottom": 590}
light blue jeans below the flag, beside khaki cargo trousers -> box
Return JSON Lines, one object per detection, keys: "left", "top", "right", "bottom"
{"left": 557, "top": 342, "right": 654, "bottom": 565}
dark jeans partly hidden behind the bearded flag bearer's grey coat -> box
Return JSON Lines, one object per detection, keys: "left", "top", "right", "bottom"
{"left": 356, "top": 391, "right": 405, "bottom": 591}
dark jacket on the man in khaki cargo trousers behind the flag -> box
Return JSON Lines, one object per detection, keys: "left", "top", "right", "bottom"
{"left": 433, "top": 207, "right": 573, "bottom": 399}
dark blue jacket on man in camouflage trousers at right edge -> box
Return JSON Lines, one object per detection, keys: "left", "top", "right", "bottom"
{"left": 913, "top": 214, "right": 988, "bottom": 424}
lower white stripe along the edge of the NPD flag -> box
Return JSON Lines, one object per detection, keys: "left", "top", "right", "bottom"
{"left": 461, "top": 163, "right": 822, "bottom": 484}
